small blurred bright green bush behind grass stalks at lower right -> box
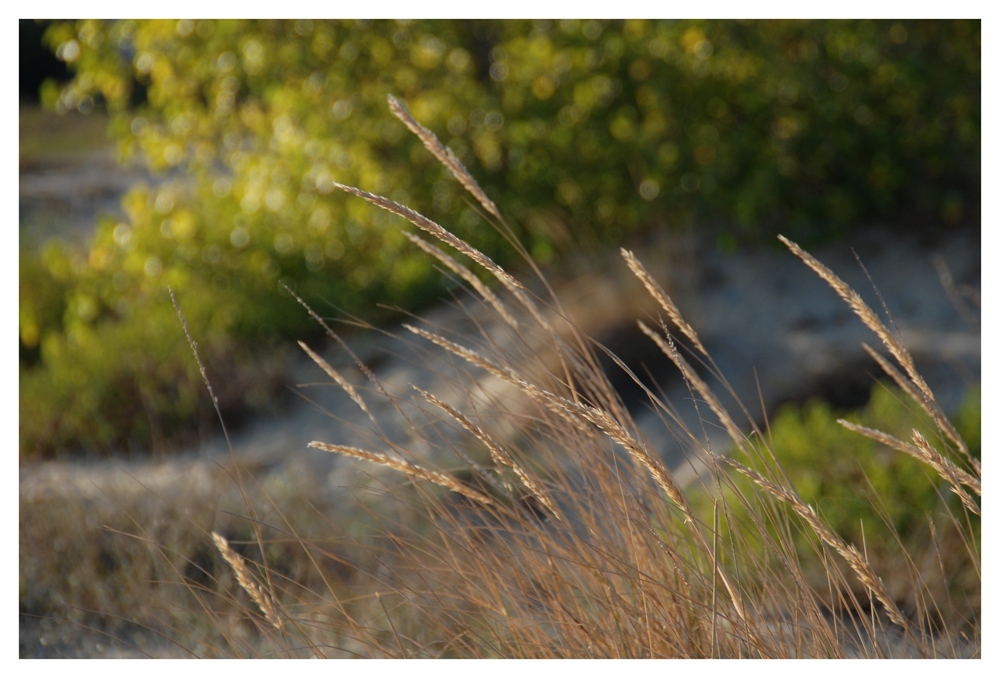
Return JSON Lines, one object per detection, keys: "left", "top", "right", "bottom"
{"left": 694, "top": 385, "right": 982, "bottom": 595}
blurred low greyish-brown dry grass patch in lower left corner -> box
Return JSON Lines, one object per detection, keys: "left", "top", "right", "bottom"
{"left": 18, "top": 460, "right": 365, "bottom": 657}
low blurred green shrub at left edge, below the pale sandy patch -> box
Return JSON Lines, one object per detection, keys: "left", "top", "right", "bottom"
{"left": 19, "top": 240, "right": 292, "bottom": 456}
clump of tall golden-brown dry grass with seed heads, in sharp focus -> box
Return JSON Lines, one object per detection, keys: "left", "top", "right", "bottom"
{"left": 189, "top": 99, "right": 981, "bottom": 657}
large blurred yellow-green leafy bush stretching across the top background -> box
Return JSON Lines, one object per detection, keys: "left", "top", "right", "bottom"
{"left": 21, "top": 20, "right": 981, "bottom": 460}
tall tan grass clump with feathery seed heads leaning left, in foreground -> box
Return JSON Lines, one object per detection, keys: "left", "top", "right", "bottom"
{"left": 199, "top": 97, "right": 982, "bottom": 658}
